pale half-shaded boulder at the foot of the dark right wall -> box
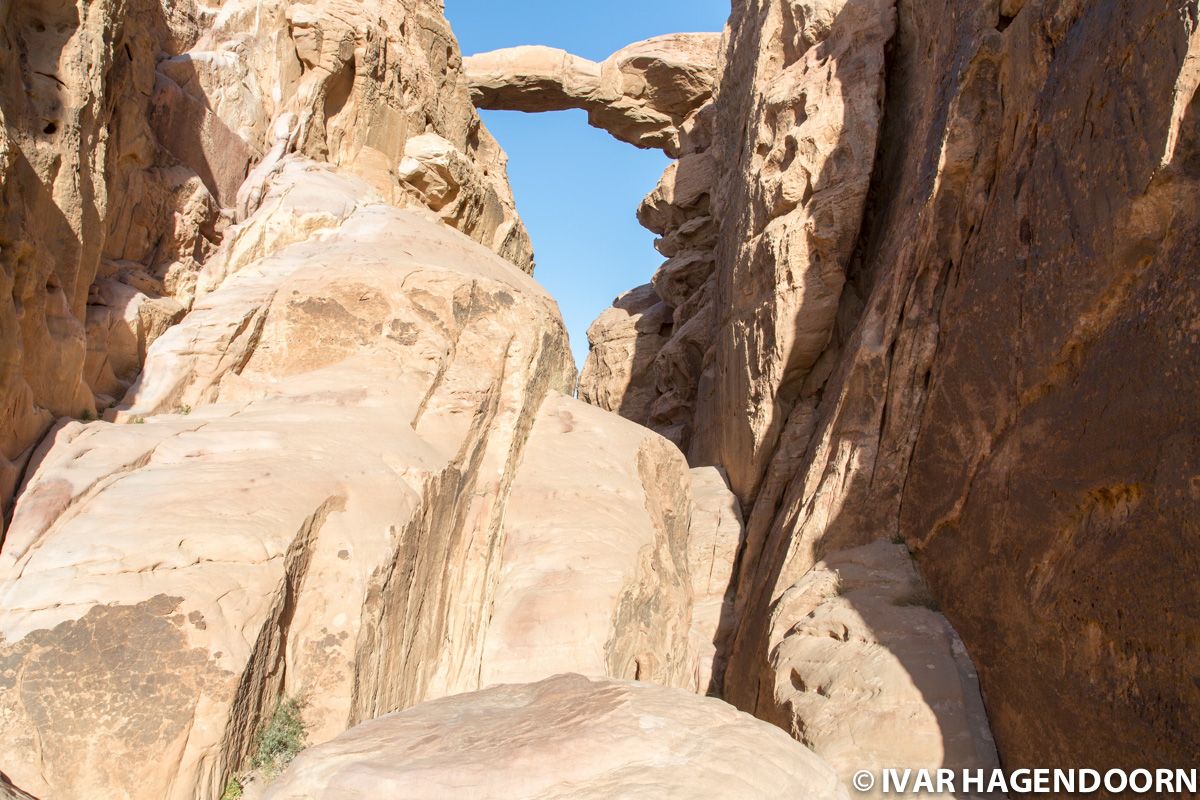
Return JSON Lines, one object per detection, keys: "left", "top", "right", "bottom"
{"left": 760, "top": 542, "right": 1000, "bottom": 796}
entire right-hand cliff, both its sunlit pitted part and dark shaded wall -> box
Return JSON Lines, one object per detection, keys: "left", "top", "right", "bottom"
{"left": 559, "top": 0, "right": 1200, "bottom": 782}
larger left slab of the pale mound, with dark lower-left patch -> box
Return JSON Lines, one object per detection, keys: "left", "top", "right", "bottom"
{"left": 0, "top": 160, "right": 572, "bottom": 799}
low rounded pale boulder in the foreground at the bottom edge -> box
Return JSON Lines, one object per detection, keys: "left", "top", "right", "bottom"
{"left": 266, "top": 675, "right": 848, "bottom": 800}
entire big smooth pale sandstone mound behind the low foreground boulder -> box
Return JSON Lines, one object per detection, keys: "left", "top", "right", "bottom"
{"left": 0, "top": 157, "right": 740, "bottom": 798}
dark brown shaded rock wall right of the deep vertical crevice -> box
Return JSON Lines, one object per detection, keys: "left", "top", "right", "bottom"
{"left": 709, "top": 2, "right": 1200, "bottom": 769}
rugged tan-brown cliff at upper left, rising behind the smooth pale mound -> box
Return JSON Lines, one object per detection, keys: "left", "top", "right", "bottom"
{"left": 0, "top": 0, "right": 532, "bottom": 512}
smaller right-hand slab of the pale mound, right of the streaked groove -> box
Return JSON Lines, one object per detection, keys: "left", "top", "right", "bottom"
{"left": 480, "top": 396, "right": 696, "bottom": 686}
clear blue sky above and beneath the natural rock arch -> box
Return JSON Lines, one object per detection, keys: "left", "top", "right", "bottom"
{"left": 445, "top": 0, "right": 730, "bottom": 368}
